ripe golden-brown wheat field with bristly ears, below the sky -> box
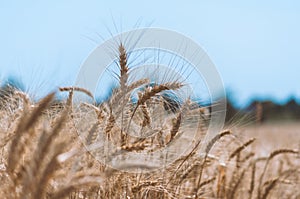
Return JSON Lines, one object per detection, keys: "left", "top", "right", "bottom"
{"left": 0, "top": 44, "right": 300, "bottom": 199}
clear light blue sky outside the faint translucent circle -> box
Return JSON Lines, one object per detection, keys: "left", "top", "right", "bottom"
{"left": 0, "top": 0, "right": 300, "bottom": 107}
